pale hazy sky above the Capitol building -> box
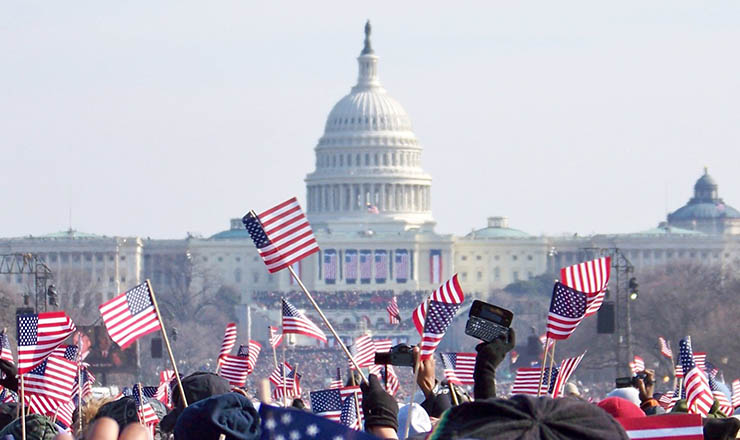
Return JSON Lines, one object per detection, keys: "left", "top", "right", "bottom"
{"left": 0, "top": 0, "right": 740, "bottom": 238}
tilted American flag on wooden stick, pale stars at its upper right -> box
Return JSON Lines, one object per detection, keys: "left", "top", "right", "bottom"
{"left": 99, "top": 280, "right": 161, "bottom": 349}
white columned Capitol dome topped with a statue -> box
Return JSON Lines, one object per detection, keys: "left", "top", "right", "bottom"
{"left": 306, "top": 22, "right": 434, "bottom": 232}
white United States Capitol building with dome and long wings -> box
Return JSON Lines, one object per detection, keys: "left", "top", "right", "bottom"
{"left": 0, "top": 26, "right": 740, "bottom": 335}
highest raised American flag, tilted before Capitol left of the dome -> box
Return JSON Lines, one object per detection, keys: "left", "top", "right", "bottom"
{"left": 242, "top": 197, "right": 319, "bottom": 273}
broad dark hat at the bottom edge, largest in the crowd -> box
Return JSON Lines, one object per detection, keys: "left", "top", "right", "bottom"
{"left": 430, "top": 395, "right": 628, "bottom": 440}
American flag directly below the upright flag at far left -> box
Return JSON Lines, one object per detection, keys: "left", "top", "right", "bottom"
{"left": 23, "top": 356, "right": 77, "bottom": 402}
